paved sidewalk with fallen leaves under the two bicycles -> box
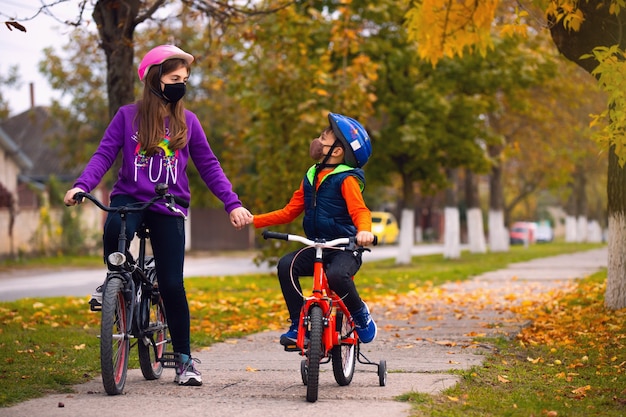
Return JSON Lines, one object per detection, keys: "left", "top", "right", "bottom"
{"left": 0, "top": 248, "right": 608, "bottom": 417}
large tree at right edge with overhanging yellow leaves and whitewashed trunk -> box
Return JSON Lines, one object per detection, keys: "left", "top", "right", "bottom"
{"left": 407, "top": 0, "right": 626, "bottom": 309}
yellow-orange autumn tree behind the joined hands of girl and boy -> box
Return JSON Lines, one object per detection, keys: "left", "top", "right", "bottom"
{"left": 227, "top": 0, "right": 376, "bottom": 255}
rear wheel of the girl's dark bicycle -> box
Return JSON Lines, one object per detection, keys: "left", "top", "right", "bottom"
{"left": 137, "top": 268, "right": 168, "bottom": 380}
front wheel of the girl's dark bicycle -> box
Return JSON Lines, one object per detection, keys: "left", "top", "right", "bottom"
{"left": 100, "top": 276, "right": 130, "bottom": 395}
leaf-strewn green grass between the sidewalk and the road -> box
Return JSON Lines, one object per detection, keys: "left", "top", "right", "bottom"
{"left": 0, "top": 243, "right": 608, "bottom": 408}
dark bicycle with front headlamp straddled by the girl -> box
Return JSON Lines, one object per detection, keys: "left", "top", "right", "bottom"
{"left": 74, "top": 184, "right": 189, "bottom": 395}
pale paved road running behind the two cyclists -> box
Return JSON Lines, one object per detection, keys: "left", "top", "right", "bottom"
{"left": 0, "top": 245, "right": 443, "bottom": 301}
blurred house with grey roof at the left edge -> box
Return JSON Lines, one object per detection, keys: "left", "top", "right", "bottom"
{"left": 0, "top": 107, "right": 95, "bottom": 257}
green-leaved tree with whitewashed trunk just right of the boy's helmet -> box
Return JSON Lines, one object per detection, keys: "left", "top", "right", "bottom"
{"left": 351, "top": 1, "right": 487, "bottom": 264}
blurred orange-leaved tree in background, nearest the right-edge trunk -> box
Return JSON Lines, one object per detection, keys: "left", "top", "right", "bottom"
{"left": 501, "top": 60, "right": 606, "bottom": 237}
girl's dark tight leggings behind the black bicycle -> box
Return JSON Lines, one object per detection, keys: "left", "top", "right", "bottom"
{"left": 103, "top": 195, "right": 191, "bottom": 355}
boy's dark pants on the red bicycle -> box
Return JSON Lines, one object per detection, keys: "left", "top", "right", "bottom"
{"left": 278, "top": 248, "right": 363, "bottom": 323}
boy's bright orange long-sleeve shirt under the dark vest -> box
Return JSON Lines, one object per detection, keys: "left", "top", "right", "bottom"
{"left": 254, "top": 168, "right": 372, "bottom": 232}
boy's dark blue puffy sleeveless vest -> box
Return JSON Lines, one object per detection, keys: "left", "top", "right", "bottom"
{"left": 302, "top": 164, "right": 365, "bottom": 240}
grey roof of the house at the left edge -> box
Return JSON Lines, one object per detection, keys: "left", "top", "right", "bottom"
{"left": 0, "top": 106, "right": 82, "bottom": 182}
